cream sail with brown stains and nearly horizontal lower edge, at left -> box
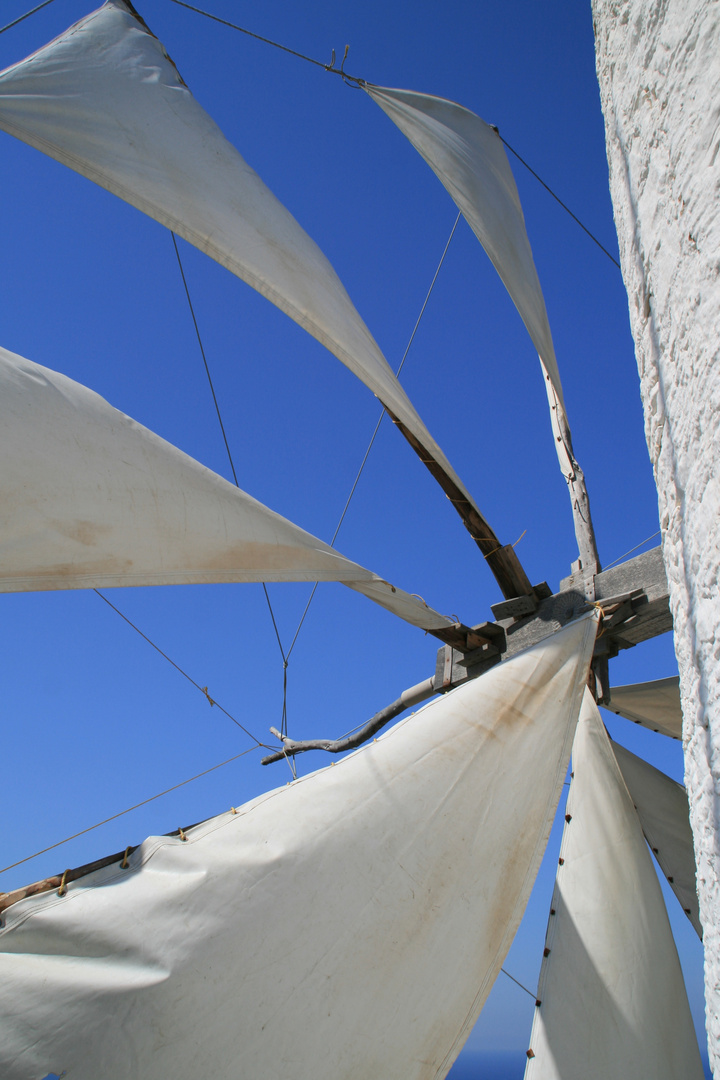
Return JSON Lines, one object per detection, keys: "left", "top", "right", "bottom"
{"left": 0, "top": 349, "right": 451, "bottom": 630}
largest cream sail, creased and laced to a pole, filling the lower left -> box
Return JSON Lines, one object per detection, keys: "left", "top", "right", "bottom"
{"left": 0, "top": 616, "right": 597, "bottom": 1080}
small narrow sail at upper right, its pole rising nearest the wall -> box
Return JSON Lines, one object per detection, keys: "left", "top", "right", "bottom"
{"left": 364, "top": 83, "right": 565, "bottom": 407}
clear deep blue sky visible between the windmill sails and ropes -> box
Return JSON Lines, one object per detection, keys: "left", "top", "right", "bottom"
{"left": 0, "top": 0, "right": 703, "bottom": 1067}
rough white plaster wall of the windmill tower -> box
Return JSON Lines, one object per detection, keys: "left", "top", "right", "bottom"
{"left": 593, "top": 0, "right": 720, "bottom": 1062}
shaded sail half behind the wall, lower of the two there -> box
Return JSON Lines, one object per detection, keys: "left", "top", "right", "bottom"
{"left": 612, "top": 742, "right": 703, "bottom": 939}
